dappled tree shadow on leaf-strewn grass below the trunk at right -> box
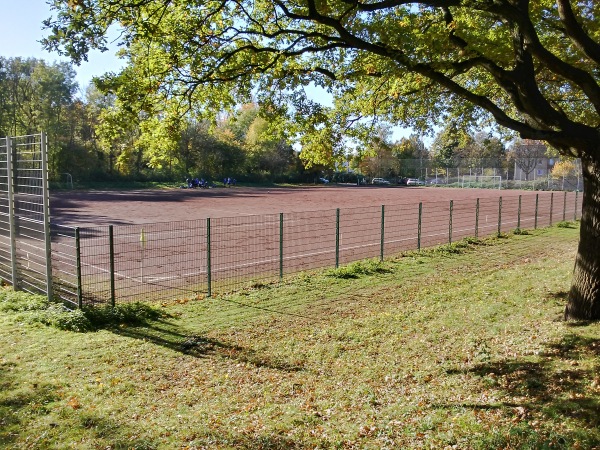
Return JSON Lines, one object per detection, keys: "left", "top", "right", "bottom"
{"left": 443, "top": 334, "right": 600, "bottom": 448}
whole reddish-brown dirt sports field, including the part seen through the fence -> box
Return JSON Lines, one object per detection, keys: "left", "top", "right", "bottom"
{"left": 50, "top": 186, "right": 580, "bottom": 302}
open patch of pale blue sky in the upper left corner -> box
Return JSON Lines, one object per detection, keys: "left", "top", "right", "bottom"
{"left": 0, "top": 0, "right": 122, "bottom": 89}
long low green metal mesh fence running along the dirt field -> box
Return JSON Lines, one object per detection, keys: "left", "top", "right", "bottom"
{"left": 15, "top": 188, "right": 581, "bottom": 306}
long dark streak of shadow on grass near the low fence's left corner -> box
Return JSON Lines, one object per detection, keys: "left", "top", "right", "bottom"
{"left": 111, "top": 320, "right": 304, "bottom": 372}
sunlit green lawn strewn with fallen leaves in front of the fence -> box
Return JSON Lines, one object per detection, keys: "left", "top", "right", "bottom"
{"left": 0, "top": 223, "right": 600, "bottom": 449}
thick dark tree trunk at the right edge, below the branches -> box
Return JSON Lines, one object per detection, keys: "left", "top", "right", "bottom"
{"left": 565, "top": 160, "right": 600, "bottom": 320}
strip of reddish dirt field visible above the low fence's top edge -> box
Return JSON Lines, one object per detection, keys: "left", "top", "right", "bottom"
{"left": 50, "top": 185, "right": 531, "bottom": 227}
